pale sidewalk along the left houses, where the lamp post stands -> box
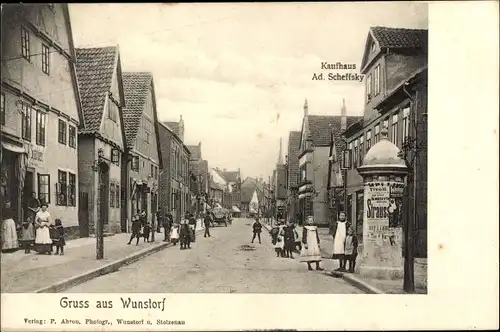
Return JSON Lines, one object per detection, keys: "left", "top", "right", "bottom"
{"left": 1, "top": 225, "right": 203, "bottom": 293}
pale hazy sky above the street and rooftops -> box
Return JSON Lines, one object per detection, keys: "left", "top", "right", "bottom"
{"left": 69, "top": 2, "right": 428, "bottom": 179}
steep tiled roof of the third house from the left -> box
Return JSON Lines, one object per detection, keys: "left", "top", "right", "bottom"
{"left": 123, "top": 72, "right": 153, "bottom": 147}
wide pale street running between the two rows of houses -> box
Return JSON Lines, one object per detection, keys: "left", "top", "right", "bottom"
{"left": 66, "top": 218, "right": 362, "bottom": 294}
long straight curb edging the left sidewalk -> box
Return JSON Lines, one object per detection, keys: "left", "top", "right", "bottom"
{"left": 33, "top": 229, "right": 203, "bottom": 293}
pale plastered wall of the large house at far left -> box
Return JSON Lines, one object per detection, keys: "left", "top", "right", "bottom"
{"left": 1, "top": 4, "right": 80, "bottom": 233}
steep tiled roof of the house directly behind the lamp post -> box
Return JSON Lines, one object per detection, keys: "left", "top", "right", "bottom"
{"left": 75, "top": 46, "right": 118, "bottom": 133}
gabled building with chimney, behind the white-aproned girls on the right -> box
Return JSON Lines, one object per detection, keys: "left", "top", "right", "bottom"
{"left": 298, "top": 100, "right": 359, "bottom": 225}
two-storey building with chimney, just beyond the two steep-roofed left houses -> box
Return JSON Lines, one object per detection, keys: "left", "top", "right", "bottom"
{"left": 158, "top": 116, "right": 191, "bottom": 221}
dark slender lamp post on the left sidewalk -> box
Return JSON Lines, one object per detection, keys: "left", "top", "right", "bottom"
{"left": 92, "top": 148, "right": 110, "bottom": 259}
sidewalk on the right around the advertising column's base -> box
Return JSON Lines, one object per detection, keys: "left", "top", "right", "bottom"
{"left": 263, "top": 224, "right": 427, "bottom": 294}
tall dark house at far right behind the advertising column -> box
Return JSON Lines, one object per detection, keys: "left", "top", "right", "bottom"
{"left": 345, "top": 27, "right": 428, "bottom": 258}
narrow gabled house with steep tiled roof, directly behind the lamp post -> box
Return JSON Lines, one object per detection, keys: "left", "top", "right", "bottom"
{"left": 76, "top": 46, "right": 127, "bottom": 236}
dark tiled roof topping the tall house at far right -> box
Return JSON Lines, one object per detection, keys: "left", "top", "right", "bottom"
{"left": 370, "top": 26, "right": 428, "bottom": 48}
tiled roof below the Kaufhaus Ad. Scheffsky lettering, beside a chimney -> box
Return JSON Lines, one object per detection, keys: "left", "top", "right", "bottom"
{"left": 307, "top": 115, "right": 361, "bottom": 146}
